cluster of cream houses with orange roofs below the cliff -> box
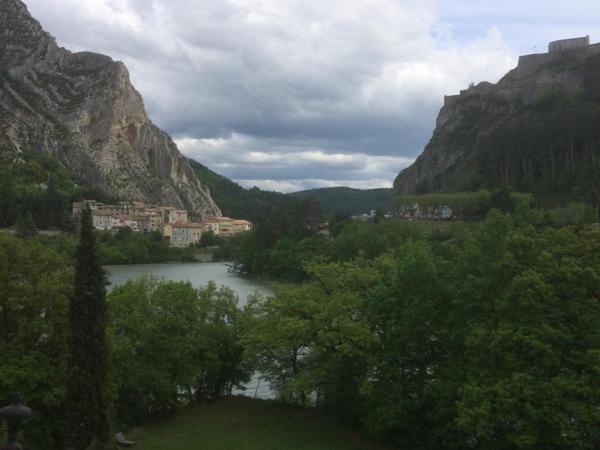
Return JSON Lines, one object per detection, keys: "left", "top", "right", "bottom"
{"left": 73, "top": 200, "right": 252, "bottom": 247}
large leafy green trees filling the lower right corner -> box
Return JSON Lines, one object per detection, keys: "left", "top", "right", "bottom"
{"left": 457, "top": 222, "right": 600, "bottom": 448}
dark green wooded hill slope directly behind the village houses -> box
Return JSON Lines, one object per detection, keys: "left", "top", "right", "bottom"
{"left": 188, "top": 159, "right": 299, "bottom": 220}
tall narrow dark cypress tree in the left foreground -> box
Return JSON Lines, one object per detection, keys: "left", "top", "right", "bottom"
{"left": 66, "top": 208, "right": 108, "bottom": 450}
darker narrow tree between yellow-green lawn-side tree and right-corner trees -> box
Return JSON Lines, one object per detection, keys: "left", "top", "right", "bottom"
{"left": 362, "top": 241, "right": 451, "bottom": 448}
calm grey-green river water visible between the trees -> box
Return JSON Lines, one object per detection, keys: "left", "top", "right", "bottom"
{"left": 104, "top": 262, "right": 275, "bottom": 398}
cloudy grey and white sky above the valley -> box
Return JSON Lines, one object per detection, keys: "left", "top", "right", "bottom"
{"left": 25, "top": 0, "right": 600, "bottom": 192}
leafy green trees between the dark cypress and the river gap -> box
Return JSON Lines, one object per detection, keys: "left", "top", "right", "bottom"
{"left": 109, "top": 278, "right": 249, "bottom": 424}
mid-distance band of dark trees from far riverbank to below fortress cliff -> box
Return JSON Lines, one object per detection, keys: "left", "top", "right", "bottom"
{"left": 215, "top": 190, "right": 596, "bottom": 282}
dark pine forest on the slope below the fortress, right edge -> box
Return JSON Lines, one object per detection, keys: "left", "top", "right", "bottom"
{"left": 476, "top": 90, "right": 600, "bottom": 205}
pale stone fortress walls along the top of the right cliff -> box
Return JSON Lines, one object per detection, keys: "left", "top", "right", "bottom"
{"left": 444, "top": 36, "right": 600, "bottom": 108}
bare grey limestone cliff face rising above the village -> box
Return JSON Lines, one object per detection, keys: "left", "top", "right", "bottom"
{"left": 0, "top": 0, "right": 220, "bottom": 216}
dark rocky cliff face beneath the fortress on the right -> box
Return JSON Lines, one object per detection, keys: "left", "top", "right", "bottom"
{"left": 394, "top": 40, "right": 600, "bottom": 194}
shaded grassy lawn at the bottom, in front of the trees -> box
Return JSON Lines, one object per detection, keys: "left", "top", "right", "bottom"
{"left": 134, "top": 397, "right": 370, "bottom": 450}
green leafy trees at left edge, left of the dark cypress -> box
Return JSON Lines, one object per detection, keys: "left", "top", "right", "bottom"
{"left": 0, "top": 234, "right": 73, "bottom": 449}
